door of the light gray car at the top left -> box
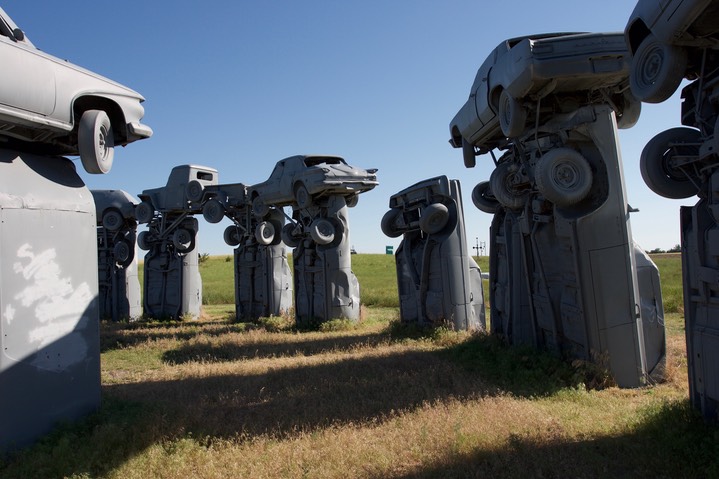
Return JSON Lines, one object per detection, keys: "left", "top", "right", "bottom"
{"left": 0, "top": 13, "right": 55, "bottom": 116}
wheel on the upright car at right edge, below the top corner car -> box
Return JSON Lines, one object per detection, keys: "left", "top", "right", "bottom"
{"left": 639, "top": 127, "right": 701, "bottom": 199}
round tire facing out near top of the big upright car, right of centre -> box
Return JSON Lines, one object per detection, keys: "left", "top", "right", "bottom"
{"left": 534, "top": 148, "right": 594, "bottom": 207}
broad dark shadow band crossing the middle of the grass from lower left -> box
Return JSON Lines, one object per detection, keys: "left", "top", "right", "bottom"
{"left": 0, "top": 335, "right": 696, "bottom": 478}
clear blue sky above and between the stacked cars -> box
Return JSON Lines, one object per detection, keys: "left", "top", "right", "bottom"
{"left": 2, "top": 0, "right": 696, "bottom": 254}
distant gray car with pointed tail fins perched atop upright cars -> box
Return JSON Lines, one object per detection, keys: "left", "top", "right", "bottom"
{"left": 248, "top": 155, "right": 379, "bottom": 216}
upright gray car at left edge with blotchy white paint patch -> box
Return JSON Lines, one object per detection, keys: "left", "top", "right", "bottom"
{"left": 0, "top": 150, "right": 100, "bottom": 450}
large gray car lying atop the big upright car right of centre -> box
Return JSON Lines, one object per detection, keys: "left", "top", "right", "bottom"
{"left": 449, "top": 33, "right": 641, "bottom": 167}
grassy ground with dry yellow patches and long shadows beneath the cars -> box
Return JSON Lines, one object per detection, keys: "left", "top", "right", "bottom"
{"left": 0, "top": 255, "right": 719, "bottom": 479}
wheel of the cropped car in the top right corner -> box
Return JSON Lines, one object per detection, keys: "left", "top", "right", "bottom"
{"left": 629, "top": 34, "right": 687, "bottom": 103}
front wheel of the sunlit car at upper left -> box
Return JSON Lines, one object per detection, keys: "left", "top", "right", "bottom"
{"left": 77, "top": 110, "right": 115, "bottom": 175}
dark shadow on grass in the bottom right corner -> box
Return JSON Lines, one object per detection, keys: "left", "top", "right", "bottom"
{"left": 382, "top": 401, "right": 719, "bottom": 479}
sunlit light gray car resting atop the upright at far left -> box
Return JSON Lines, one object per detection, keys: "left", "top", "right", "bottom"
{"left": 0, "top": 8, "right": 152, "bottom": 173}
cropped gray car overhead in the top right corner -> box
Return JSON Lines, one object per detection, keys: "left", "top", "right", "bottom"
{"left": 625, "top": 0, "right": 719, "bottom": 103}
